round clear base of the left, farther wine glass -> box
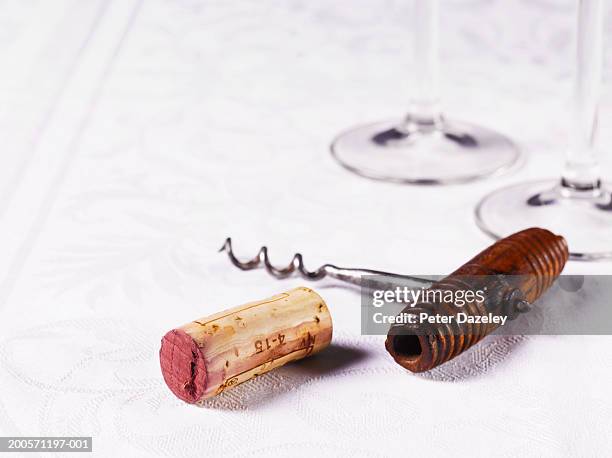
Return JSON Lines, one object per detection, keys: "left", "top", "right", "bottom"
{"left": 331, "top": 120, "right": 520, "bottom": 184}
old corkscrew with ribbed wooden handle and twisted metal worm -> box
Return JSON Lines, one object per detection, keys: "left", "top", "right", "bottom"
{"left": 219, "top": 228, "right": 569, "bottom": 372}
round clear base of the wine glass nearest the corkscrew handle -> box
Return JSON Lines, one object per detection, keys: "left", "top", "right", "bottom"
{"left": 476, "top": 180, "right": 612, "bottom": 261}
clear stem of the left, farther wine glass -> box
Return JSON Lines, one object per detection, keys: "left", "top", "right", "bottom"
{"left": 406, "top": 0, "right": 440, "bottom": 129}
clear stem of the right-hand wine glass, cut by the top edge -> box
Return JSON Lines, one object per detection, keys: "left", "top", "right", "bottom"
{"left": 561, "top": 0, "right": 603, "bottom": 191}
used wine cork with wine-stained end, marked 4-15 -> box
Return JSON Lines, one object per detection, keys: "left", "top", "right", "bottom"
{"left": 159, "top": 287, "right": 332, "bottom": 404}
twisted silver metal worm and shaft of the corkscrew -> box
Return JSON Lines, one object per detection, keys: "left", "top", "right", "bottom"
{"left": 219, "top": 237, "right": 434, "bottom": 288}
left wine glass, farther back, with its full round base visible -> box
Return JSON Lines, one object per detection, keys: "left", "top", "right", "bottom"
{"left": 331, "top": 0, "right": 519, "bottom": 184}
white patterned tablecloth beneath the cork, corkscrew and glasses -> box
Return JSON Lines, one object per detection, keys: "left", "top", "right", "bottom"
{"left": 0, "top": 0, "right": 612, "bottom": 457}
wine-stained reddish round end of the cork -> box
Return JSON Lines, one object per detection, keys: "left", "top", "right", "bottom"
{"left": 159, "top": 329, "right": 206, "bottom": 404}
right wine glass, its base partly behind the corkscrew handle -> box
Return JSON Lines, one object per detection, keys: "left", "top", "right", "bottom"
{"left": 476, "top": 0, "right": 612, "bottom": 260}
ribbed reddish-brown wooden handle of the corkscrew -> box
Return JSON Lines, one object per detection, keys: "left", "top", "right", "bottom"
{"left": 385, "top": 228, "right": 569, "bottom": 372}
